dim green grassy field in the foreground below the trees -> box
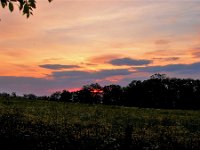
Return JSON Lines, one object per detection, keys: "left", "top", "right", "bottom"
{"left": 0, "top": 99, "right": 200, "bottom": 150}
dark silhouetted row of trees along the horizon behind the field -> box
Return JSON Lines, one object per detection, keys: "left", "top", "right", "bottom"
{"left": 0, "top": 74, "right": 200, "bottom": 109}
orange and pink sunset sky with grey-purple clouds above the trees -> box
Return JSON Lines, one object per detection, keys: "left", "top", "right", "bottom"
{"left": 0, "top": 0, "right": 200, "bottom": 95}
